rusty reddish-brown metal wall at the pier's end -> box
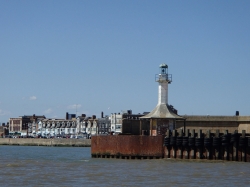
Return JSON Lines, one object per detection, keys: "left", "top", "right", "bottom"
{"left": 91, "top": 135, "right": 164, "bottom": 158}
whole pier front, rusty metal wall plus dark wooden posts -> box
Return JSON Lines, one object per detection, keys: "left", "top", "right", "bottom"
{"left": 91, "top": 129, "right": 250, "bottom": 162}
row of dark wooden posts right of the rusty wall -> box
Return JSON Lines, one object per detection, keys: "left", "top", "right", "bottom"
{"left": 164, "top": 129, "right": 250, "bottom": 162}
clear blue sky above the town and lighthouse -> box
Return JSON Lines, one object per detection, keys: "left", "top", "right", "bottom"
{"left": 0, "top": 0, "right": 250, "bottom": 123}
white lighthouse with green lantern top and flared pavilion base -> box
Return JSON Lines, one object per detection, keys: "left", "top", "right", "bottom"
{"left": 140, "top": 64, "right": 185, "bottom": 136}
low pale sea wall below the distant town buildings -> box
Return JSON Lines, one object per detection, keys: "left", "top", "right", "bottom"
{"left": 0, "top": 138, "right": 91, "bottom": 147}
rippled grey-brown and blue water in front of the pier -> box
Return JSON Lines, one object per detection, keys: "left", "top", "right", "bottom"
{"left": 0, "top": 146, "right": 250, "bottom": 187}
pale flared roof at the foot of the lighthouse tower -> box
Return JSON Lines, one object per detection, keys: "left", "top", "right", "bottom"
{"left": 140, "top": 104, "right": 185, "bottom": 120}
